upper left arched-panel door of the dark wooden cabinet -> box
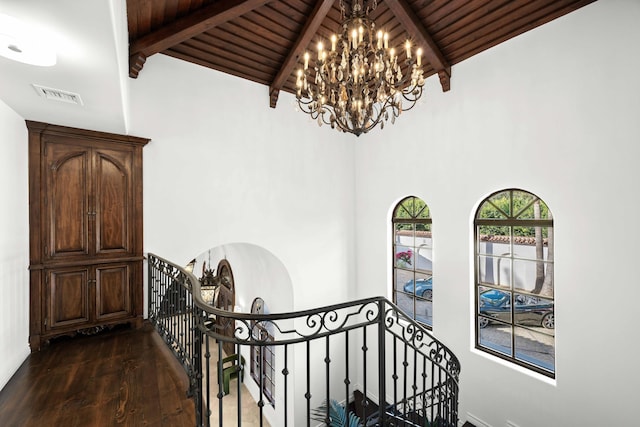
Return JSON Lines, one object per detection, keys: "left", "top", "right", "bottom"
{"left": 45, "top": 144, "right": 90, "bottom": 258}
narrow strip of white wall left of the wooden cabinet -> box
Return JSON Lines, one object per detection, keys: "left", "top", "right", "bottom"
{"left": 0, "top": 101, "right": 29, "bottom": 390}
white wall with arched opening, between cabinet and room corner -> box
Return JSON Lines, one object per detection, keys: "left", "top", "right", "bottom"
{"left": 130, "top": 55, "right": 356, "bottom": 424}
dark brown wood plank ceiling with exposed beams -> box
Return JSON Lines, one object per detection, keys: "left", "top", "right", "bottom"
{"left": 127, "top": 0, "right": 595, "bottom": 107}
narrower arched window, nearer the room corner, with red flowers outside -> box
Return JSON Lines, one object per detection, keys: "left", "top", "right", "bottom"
{"left": 392, "top": 196, "right": 433, "bottom": 328}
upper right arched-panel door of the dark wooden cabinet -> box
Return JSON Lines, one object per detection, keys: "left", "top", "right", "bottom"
{"left": 94, "top": 150, "right": 131, "bottom": 254}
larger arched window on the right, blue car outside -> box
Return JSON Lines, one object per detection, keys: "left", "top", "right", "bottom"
{"left": 474, "top": 189, "right": 555, "bottom": 378}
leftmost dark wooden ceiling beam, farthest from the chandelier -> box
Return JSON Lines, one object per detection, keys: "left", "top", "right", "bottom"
{"left": 129, "top": 0, "right": 272, "bottom": 79}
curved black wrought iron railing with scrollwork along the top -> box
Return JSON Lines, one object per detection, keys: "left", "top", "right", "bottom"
{"left": 148, "top": 254, "right": 460, "bottom": 427}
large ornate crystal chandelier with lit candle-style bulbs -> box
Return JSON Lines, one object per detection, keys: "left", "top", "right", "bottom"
{"left": 296, "top": 0, "right": 424, "bottom": 136}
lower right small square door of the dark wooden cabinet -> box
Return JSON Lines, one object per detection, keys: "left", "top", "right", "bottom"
{"left": 96, "top": 264, "right": 131, "bottom": 320}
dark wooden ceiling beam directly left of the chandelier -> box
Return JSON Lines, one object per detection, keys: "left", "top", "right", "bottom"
{"left": 269, "top": 0, "right": 335, "bottom": 108}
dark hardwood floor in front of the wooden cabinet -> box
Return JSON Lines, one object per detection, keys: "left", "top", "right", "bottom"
{"left": 0, "top": 325, "right": 195, "bottom": 427}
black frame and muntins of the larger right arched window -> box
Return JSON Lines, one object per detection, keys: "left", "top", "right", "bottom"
{"left": 473, "top": 188, "right": 557, "bottom": 379}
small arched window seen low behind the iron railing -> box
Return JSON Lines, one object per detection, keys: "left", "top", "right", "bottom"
{"left": 251, "top": 297, "right": 276, "bottom": 407}
